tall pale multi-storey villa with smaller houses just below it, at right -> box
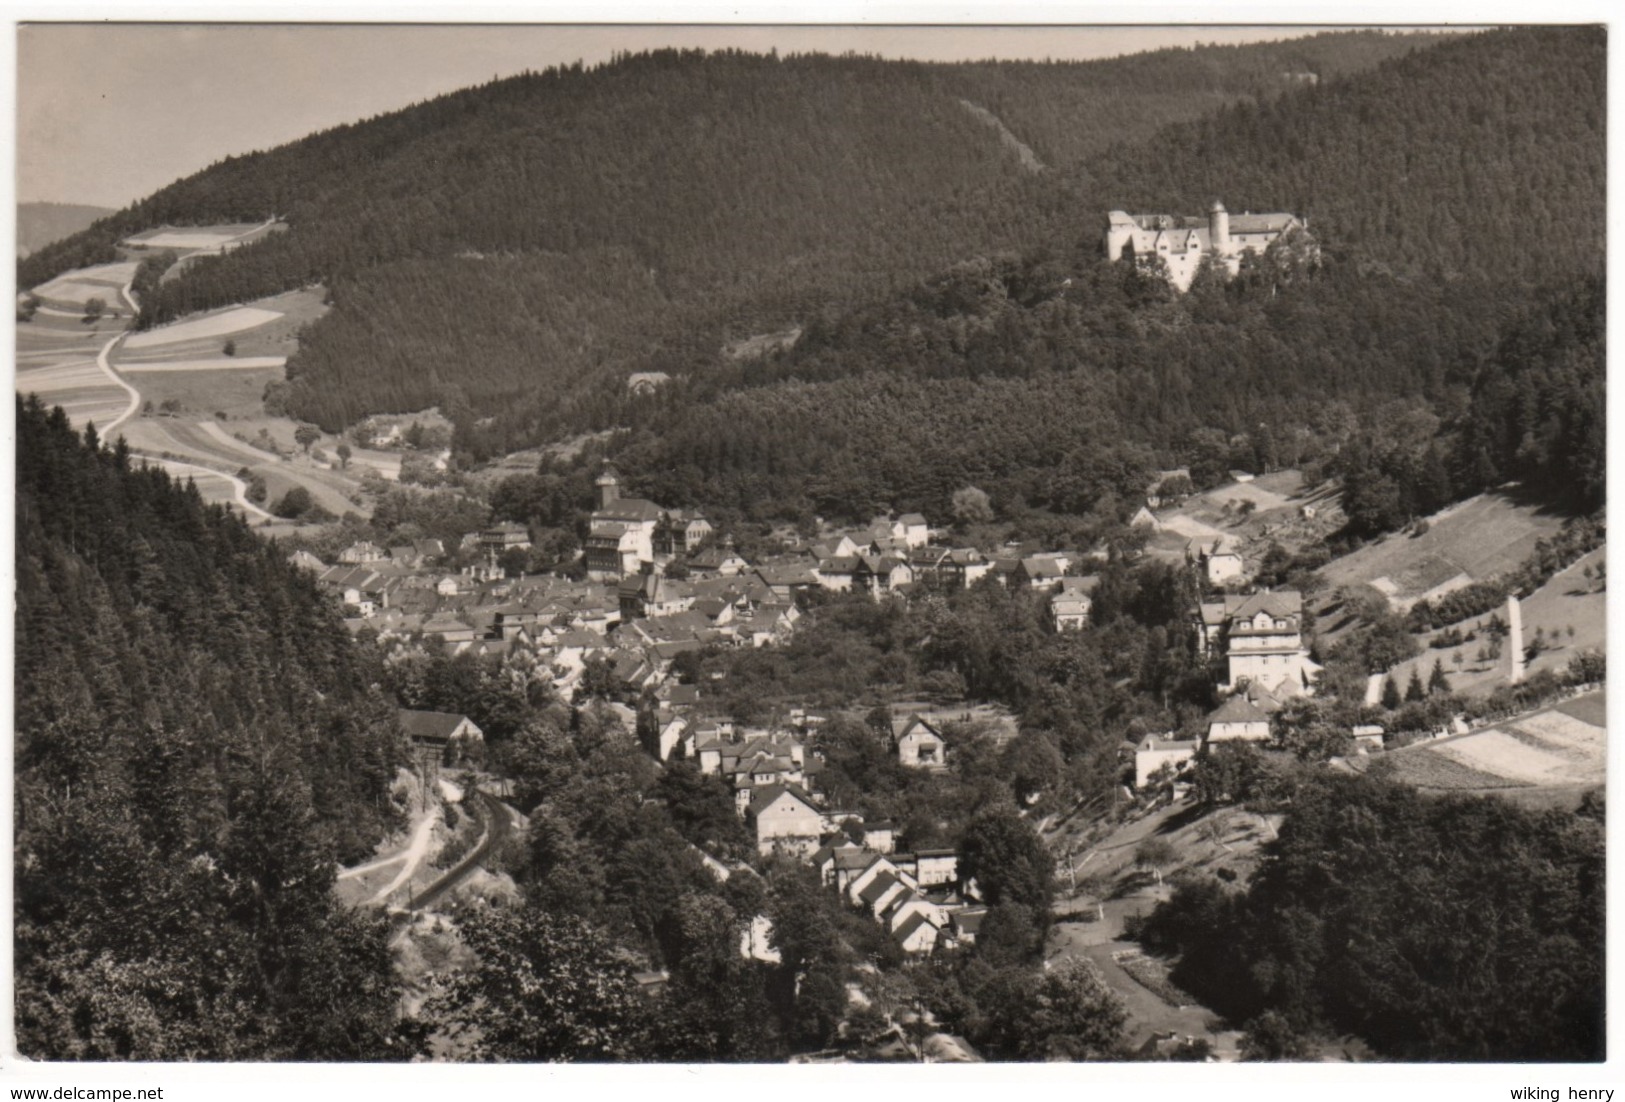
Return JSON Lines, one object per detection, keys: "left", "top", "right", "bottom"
{"left": 1133, "top": 590, "right": 1326, "bottom": 788}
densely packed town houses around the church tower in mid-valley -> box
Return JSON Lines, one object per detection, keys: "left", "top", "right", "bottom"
{"left": 302, "top": 468, "right": 1118, "bottom": 711}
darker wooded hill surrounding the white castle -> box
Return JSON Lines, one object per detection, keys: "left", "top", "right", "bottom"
{"left": 611, "top": 29, "right": 1606, "bottom": 530}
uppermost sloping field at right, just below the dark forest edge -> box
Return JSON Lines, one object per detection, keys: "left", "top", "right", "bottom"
{"left": 1321, "top": 494, "right": 1565, "bottom": 611}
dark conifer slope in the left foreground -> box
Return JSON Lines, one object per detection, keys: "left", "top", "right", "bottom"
{"left": 15, "top": 400, "right": 403, "bottom": 1060}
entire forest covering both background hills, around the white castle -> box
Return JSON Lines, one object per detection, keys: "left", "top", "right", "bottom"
{"left": 24, "top": 29, "right": 1604, "bottom": 535}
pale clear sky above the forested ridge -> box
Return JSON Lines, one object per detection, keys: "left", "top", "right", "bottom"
{"left": 16, "top": 22, "right": 1384, "bottom": 208}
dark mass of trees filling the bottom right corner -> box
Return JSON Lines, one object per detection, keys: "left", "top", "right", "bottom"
{"left": 1144, "top": 774, "right": 1606, "bottom": 1063}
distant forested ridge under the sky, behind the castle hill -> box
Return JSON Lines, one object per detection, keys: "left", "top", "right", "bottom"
{"left": 21, "top": 33, "right": 1437, "bottom": 438}
